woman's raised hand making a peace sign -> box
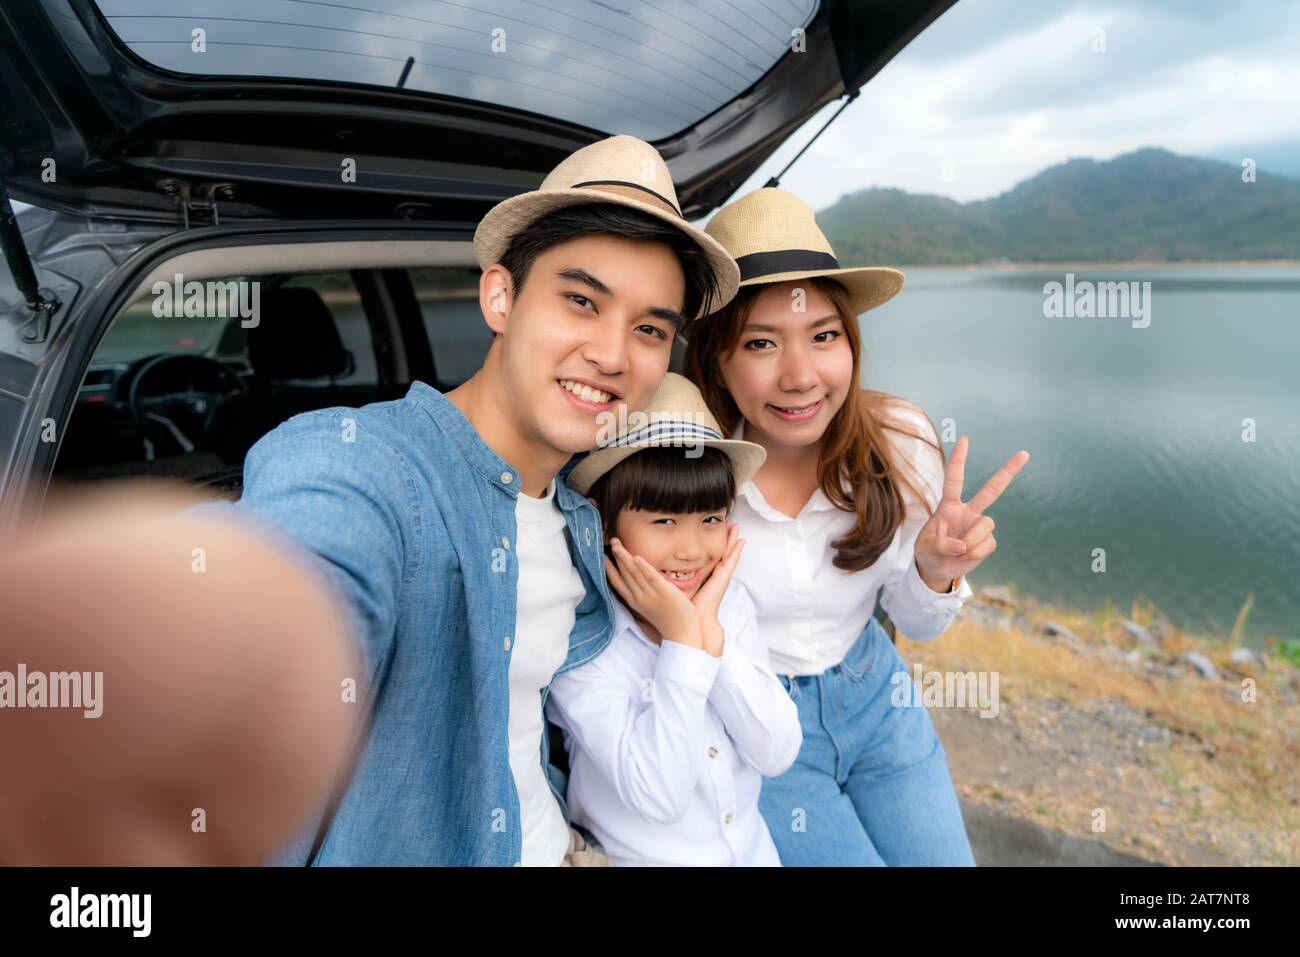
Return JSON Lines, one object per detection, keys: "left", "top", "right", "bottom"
{"left": 917, "top": 436, "right": 1030, "bottom": 592}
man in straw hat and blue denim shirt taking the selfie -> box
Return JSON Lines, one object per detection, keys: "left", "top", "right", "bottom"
{"left": 0, "top": 137, "right": 740, "bottom": 865}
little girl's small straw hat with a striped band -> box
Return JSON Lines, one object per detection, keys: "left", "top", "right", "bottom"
{"left": 568, "top": 372, "right": 767, "bottom": 495}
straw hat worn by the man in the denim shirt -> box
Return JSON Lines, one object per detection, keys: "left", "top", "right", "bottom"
{"left": 475, "top": 135, "right": 740, "bottom": 319}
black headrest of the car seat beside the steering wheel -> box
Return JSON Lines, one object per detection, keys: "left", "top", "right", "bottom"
{"left": 248, "top": 287, "right": 352, "bottom": 381}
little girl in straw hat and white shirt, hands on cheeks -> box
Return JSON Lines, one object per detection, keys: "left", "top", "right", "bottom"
{"left": 546, "top": 373, "right": 801, "bottom": 866}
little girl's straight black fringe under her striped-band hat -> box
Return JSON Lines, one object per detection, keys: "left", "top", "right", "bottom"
{"left": 586, "top": 446, "right": 736, "bottom": 536}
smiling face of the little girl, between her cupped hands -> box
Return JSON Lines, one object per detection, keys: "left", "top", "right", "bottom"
{"left": 603, "top": 508, "right": 727, "bottom": 598}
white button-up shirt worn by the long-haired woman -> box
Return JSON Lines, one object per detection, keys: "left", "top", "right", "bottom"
{"left": 731, "top": 410, "right": 971, "bottom": 675}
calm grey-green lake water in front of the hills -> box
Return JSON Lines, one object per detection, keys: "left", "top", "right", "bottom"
{"left": 862, "top": 267, "right": 1300, "bottom": 645}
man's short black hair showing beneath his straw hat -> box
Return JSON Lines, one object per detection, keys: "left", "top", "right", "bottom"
{"left": 501, "top": 203, "right": 718, "bottom": 321}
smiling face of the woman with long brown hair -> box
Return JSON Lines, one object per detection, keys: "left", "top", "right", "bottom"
{"left": 719, "top": 280, "right": 854, "bottom": 446}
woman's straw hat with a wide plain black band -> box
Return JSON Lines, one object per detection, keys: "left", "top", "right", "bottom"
{"left": 705, "top": 187, "right": 904, "bottom": 316}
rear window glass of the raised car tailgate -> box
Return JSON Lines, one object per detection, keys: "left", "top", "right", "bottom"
{"left": 99, "top": 0, "right": 819, "bottom": 140}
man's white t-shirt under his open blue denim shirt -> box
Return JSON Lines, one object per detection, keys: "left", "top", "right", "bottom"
{"left": 510, "top": 480, "right": 586, "bottom": 867}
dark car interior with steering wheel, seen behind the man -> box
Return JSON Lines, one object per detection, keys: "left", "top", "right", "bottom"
{"left": 55, "top": 257, "right": 490, "bottom": 497}
